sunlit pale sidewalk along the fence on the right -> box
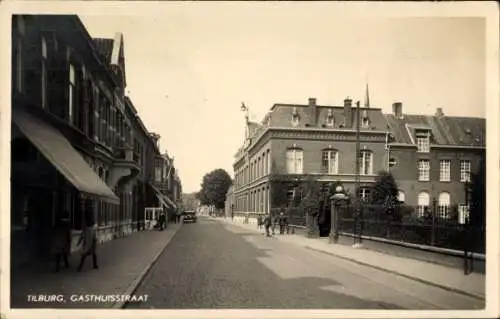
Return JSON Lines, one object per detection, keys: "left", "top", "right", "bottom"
{"left": 222, "top": 217, "right": 486, "bottom": 299}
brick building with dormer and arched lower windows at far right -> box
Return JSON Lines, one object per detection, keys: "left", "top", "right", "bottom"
{"left": 385, "top": 103, "right": 486, "bottom": 223}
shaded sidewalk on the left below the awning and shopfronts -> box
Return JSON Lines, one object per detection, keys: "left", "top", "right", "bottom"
{"left": 11, "top": 224, "right": 181, "bottom": 308}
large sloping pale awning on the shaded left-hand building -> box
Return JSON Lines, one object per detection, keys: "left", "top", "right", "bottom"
{"left": 12, "top": 110, "right": 120, "bottom": 204}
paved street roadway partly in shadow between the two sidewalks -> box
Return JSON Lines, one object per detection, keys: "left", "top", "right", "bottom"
{"left": 126, "top": 217, "right": 482, "bottom": 310}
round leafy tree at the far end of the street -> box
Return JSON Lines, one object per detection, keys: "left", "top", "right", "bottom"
{"left": 197, "top": 168, "right": 233, "bottom": 209}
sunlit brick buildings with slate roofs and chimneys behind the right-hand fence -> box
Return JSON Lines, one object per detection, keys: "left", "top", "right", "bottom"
{"left": 226, "top": 95, "right": 486, "bottom": 222}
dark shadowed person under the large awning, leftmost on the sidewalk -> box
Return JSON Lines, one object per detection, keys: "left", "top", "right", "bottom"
{"left": 51, "top": 212, "right": 71, "bottom": 272}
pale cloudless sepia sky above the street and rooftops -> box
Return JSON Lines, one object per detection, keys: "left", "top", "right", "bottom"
{"left": 80, "top": 3, "right": 485, "bottom": 192}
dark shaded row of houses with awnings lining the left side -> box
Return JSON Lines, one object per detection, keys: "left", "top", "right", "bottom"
{"left": 11, "top": 15, "right": 182, "bottom": 263}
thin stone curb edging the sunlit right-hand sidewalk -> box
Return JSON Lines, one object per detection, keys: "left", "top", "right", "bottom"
{"left": 222, "top": 221, "right": 485, "bottom": 300}
